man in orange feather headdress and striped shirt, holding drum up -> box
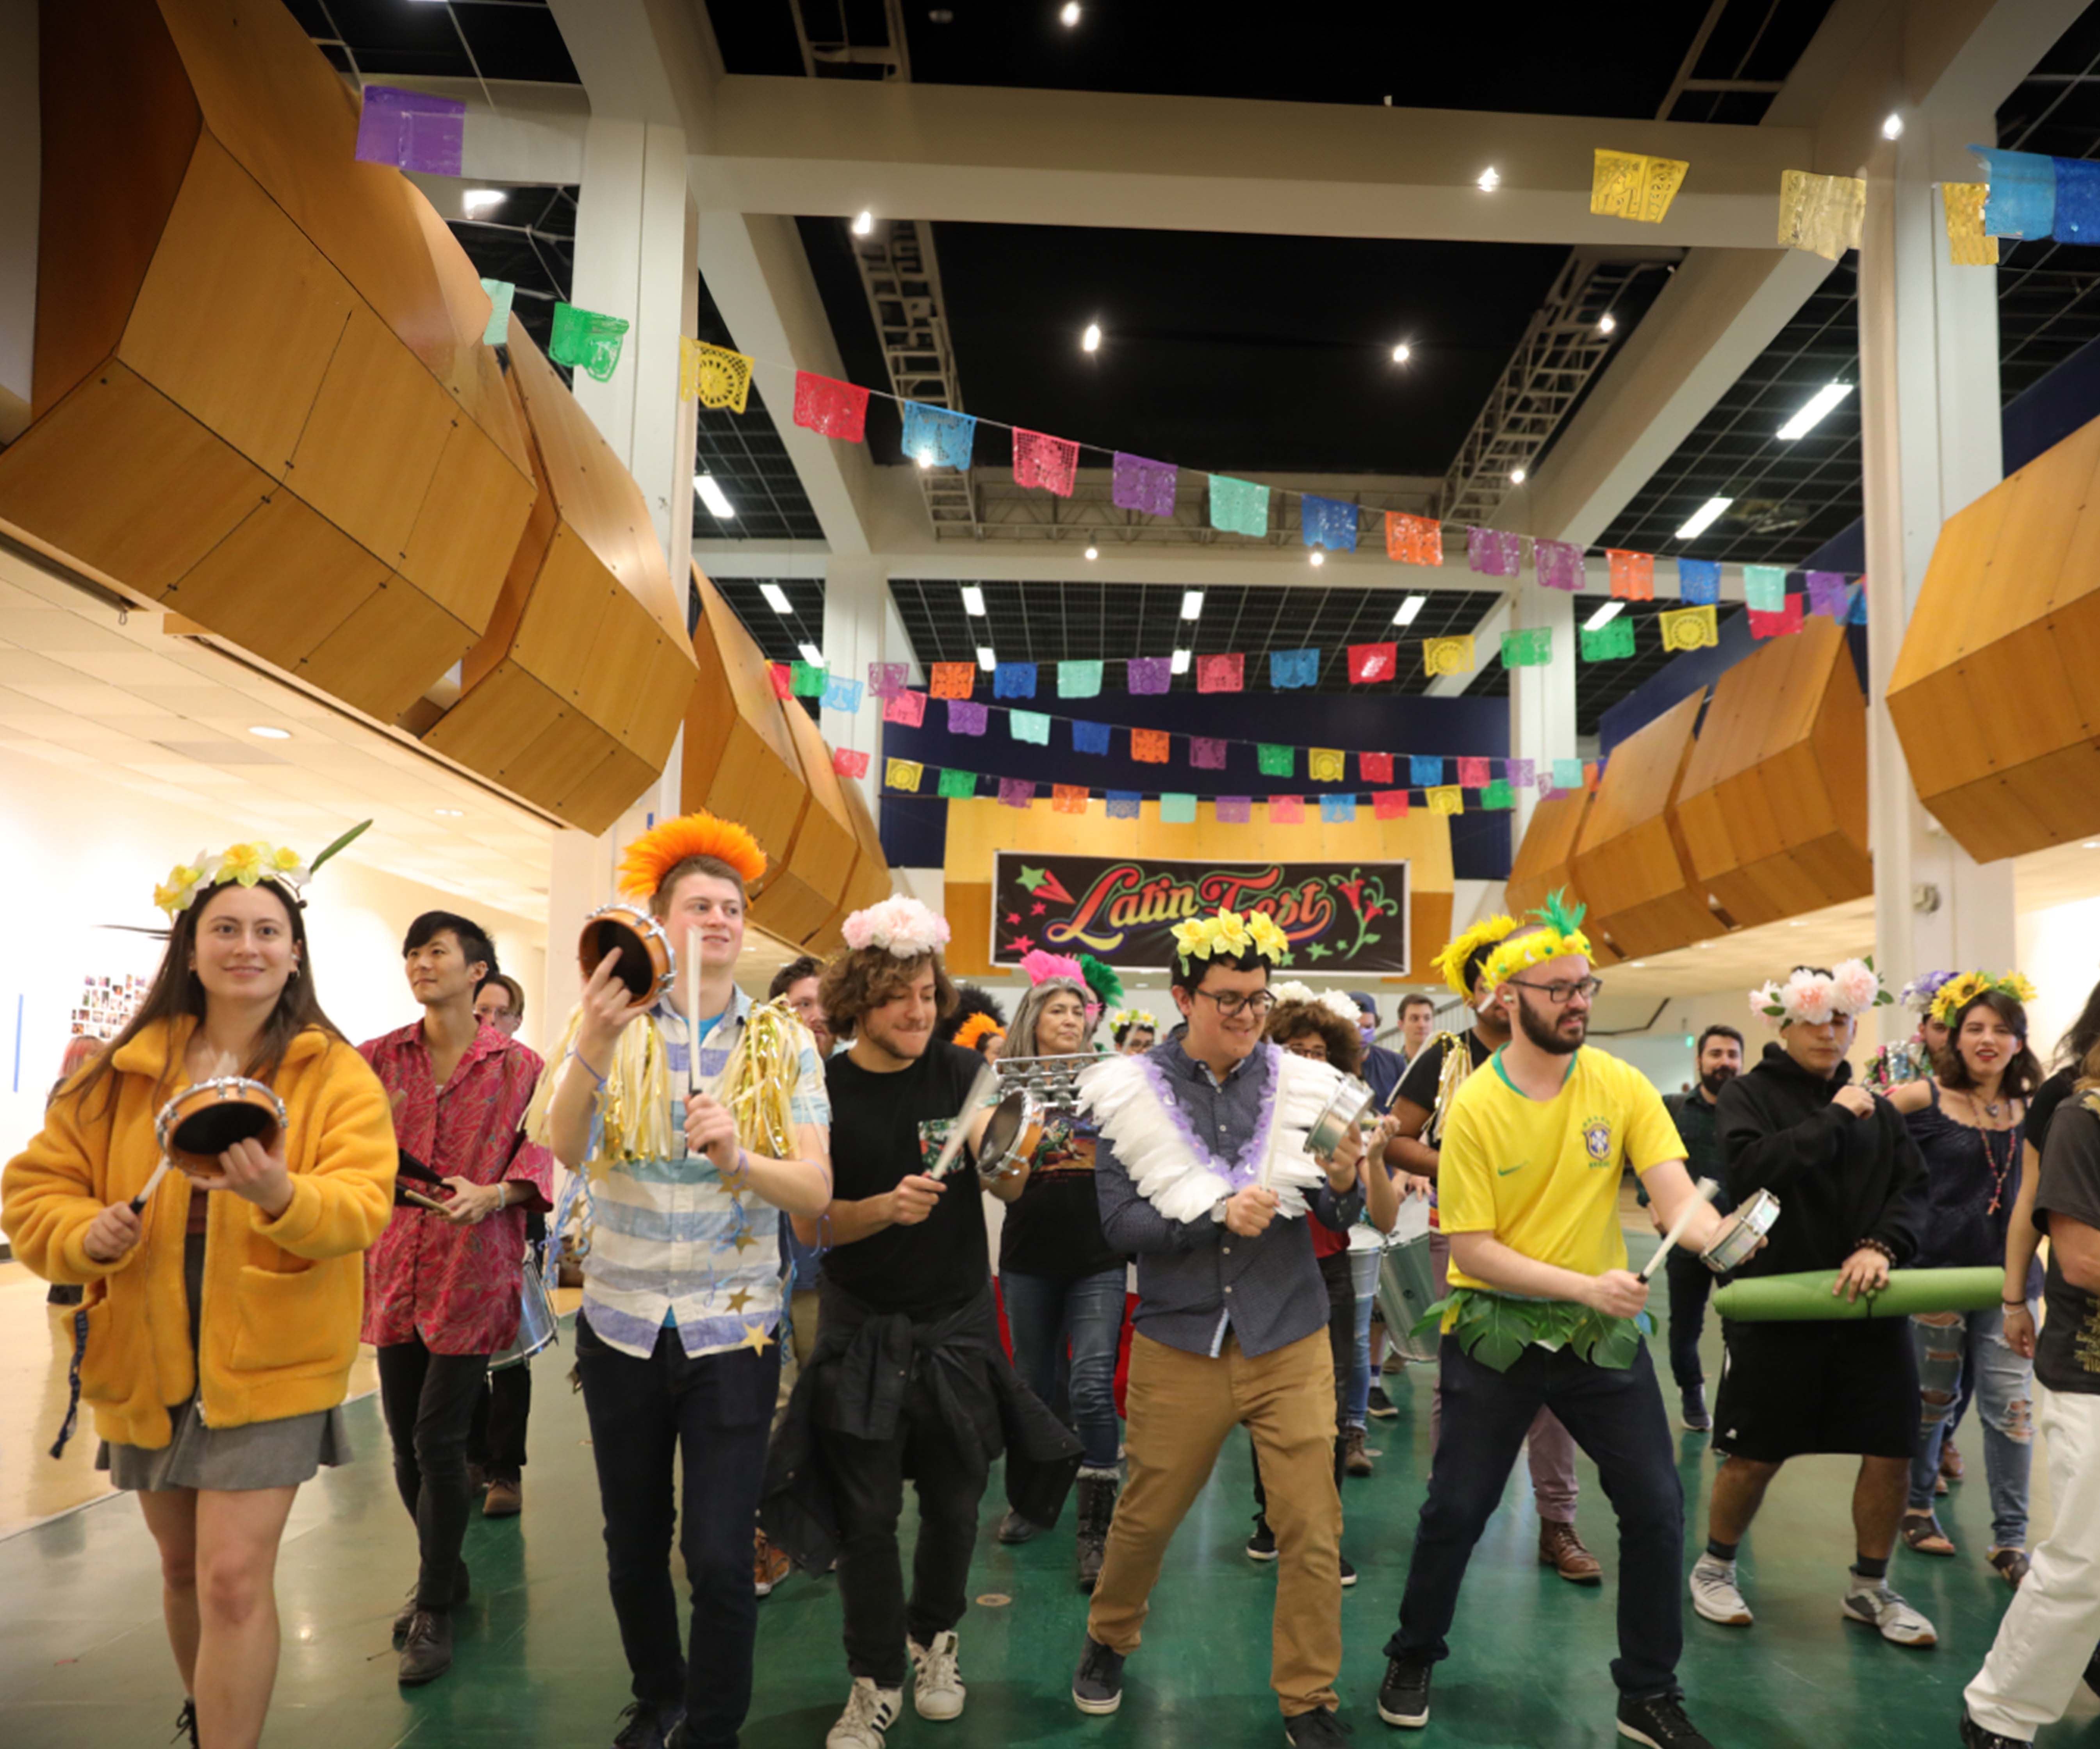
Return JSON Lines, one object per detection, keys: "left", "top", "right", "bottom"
{"left": 527, "top": 812, "right": 832, "bottom": 1749}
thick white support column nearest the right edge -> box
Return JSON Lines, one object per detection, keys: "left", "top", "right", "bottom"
{"left": 1859, "top": 103, "right": 2014, "bottom": 1037}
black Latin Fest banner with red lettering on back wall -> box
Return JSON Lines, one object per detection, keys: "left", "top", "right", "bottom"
{"left": 991, "top": 850, "right": 1411, "bottom": 976}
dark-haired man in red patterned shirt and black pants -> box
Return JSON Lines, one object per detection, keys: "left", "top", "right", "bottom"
{"left": 357, "top": 911, "right": 552, "bottom": 1686}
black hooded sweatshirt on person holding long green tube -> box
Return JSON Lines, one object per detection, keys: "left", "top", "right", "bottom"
{"left": 1718, "top": 1044, "right": 1926, "bottom": 1275}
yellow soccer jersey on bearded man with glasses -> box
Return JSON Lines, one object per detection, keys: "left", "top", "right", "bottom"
{"left": 1437, "top": 1045, "right": 1684, "bottom": 1287}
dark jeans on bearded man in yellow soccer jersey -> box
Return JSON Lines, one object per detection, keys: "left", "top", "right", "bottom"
{"left": 1386, "top": 1336, "right": 1684, "bottom": 1697}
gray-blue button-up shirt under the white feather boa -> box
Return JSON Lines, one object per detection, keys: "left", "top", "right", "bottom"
{"left": 1094, "top": 1029, "right": 1363, "bottom": 1354}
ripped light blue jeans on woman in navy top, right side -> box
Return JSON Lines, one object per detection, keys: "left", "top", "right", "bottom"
{"left": 1911, "top": 1308, "right": 2035, "bottom": 1550}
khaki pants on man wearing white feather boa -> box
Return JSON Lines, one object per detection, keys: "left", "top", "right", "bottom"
{"left": 1086, "top": 1329, "right": 1342, "bottom": 1717}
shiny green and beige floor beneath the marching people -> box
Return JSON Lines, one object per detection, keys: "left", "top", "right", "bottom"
{"left": 0, "top": 1234, "right": 2100, "bottom": 1749}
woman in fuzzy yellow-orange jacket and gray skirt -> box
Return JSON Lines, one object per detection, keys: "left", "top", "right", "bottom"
{"left": 0, "top": 840, "right": 395, "bottom": 1749}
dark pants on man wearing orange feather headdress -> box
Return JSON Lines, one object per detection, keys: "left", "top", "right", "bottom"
{"left": 576, "top": 1312, "right": 781, "bottom": 1749}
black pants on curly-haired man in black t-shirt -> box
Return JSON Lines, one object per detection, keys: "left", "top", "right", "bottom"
{"left": 815, "top": 1379, "right": 985, "bottom": 1688}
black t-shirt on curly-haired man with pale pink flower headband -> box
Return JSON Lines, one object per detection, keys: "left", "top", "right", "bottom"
{"left": 823, "top": 1044, "right": 991, "bottom": 1312}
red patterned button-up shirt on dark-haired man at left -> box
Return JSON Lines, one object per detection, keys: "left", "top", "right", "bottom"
{"left": 359, "top": 1021, "right": 554, "bottom": 1354}
